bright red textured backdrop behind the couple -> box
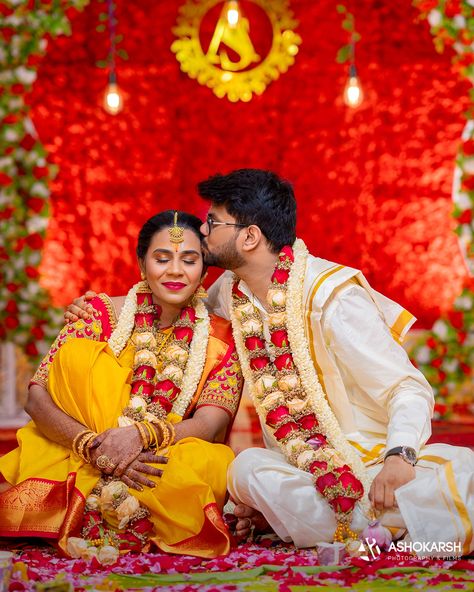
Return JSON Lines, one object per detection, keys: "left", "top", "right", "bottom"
{"left": 29, "top": 0, "right": 468, "bottom": 327}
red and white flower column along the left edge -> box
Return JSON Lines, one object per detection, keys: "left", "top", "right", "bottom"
{"left": 0, "top": 0, "right": 88, "bottom": 359}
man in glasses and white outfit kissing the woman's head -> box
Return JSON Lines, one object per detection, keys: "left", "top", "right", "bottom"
{"left": 70, "top": 169, "right": 474, "bottom": 554}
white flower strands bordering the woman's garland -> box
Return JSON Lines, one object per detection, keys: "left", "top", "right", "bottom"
{"left": 108, "top": 282, "right": 210, "bottom": 417}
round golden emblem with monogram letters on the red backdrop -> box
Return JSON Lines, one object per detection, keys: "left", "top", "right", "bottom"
{"left": 171, "top": 0, "right": 301, "bottom": 102}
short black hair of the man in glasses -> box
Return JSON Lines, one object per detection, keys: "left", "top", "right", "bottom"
{"left": 197, "top": 169, "right": 296, "bottom": 253}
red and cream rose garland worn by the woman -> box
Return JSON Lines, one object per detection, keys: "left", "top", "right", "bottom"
{"left": 67, "top": 282, "right": 210, "bottom": 565}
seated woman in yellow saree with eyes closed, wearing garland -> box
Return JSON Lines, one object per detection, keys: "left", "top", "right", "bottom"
{"left": 0, "top": 210, "right": 242, "bottom": 564}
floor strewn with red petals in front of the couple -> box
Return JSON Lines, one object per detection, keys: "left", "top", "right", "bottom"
{"left": 0, "top": 539, "right": 474, "bottom": 592}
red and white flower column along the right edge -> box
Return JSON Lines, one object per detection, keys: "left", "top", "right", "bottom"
{"left": 412, "top": 0, "right": 474, "bottom": 419}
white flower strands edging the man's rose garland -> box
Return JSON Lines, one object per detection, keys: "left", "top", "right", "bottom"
{"left": 230, "top": 239, "right": 370, "bottom": 513}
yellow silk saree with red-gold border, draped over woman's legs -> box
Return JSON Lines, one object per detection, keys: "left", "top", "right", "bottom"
{"left": 0, "top": 339, "right": 233, "bottom": 557}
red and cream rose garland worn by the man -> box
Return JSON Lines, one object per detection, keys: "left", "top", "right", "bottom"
{"left": 231, "top": 240, "right": 368, "bottom": 540}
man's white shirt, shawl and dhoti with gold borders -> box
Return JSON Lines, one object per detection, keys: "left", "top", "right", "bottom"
{"left": 209, "top": 256, "right": 474, "bottom": 554}
